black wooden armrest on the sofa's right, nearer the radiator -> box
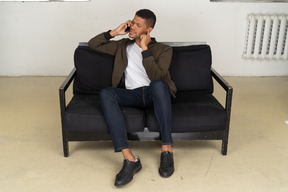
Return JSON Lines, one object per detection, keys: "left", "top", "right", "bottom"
{"left": 211, "top": 68, "right": 233, "bottom": 112}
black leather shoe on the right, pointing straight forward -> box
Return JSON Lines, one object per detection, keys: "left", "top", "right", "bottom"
{"left": 159, "top": 151, "right": 174, "bottom": 178}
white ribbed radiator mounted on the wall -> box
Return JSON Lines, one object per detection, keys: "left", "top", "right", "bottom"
{"left": 243, "top": 14, "right": 288, "bottom": 59}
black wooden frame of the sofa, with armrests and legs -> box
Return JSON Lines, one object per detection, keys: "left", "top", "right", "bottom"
{"left": 59, "top": 42, "right": 233, "bottom": 157}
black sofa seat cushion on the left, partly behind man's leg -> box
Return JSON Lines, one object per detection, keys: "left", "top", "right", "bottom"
{"left": 63, "top": 94, "right": 145, "bottom": 133}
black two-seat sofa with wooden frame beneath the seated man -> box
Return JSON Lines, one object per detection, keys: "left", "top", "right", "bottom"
{"left": 59, "top": 43, "right": 233, "bottom": 157}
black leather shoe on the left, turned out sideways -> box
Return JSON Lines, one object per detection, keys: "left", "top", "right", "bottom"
{"left": 114, "top": 157, "right": 142, "bottom": 187}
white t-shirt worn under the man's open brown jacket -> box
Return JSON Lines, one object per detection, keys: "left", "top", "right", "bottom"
{"left": 124, "top": 43, "right": 151, "bottom": 89}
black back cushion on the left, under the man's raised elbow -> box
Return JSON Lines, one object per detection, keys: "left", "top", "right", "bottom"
{"left": 73, "top": 46, "right": 114, "bottom": 94}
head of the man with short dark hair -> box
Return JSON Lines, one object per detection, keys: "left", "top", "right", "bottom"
{"left": 129, "top": 9, "right": 156, "bottom": 38}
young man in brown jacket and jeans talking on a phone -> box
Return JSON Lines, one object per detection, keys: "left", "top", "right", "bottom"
{"left": 88, "top": 9, "right": 176, "bottom": 187}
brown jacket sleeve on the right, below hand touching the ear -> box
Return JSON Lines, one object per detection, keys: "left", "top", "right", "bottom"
{"left": 142, "top": 46, "right": 172, "bottom": 81}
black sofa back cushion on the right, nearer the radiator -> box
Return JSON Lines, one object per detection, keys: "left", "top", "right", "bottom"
{"left": 170, "top": 45, "right": 213, "bottom": 93}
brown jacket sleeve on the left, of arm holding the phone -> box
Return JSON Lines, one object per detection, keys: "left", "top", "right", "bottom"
{"left": 88, "top": 31, "right": 118, "bottom": 55}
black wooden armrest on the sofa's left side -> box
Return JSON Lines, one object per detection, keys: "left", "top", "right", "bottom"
{"left": 59, "top": 68, "right": 76, "bottom": 121}
